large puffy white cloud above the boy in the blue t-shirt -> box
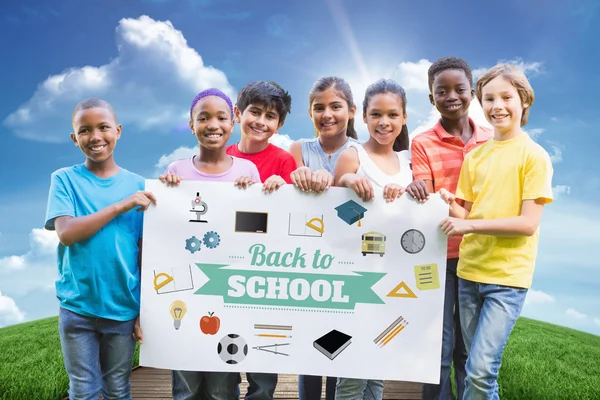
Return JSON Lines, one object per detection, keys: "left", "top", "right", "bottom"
{"left": 4, "top": 16, "right": 234, "bottom": 142}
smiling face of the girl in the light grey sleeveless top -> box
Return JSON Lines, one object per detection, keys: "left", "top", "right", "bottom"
{"left": 308, "top": 89, "right": 356, "bottom": 137}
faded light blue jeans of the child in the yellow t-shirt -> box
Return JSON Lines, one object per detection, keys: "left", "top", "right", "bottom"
{"left": 458, "top": 278, "right": 527, "bottom": 400}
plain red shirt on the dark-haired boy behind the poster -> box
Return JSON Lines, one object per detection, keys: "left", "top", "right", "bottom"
{"left": 227, "top": 143, "right": 296, "bottom": 183}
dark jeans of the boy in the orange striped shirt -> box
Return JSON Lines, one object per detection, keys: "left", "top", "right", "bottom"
{"left": 421, "top": 258, "right": 467, "bottom": 400}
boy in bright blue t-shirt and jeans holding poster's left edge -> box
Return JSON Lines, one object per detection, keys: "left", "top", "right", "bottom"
{"left": 45, "top": 98, "right": 156, "bottom": 400}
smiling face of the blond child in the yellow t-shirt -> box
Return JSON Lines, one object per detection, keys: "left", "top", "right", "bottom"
{"left": 481, "top": 75, "right": 529, "bottom": 136}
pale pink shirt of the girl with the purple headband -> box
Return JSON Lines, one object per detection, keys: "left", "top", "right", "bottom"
{"left": 165, "top": 156, "right": 261, "bottom": 183}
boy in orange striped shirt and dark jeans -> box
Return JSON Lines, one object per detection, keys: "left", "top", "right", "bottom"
{"left": 406, "top": 57, "right": 493, "bottom": 400}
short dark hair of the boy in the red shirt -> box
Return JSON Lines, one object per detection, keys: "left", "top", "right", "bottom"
{"left": 236, "top": 81, "right": 292, "bottom": 124}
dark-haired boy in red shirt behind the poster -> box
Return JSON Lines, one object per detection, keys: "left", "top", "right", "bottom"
{"left": 227, "top": 81, "right": 296, "bottom": 192}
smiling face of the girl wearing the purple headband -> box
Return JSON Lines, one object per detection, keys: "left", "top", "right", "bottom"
{"left": 190, "top": 96, "right": 233, "bottom": 150}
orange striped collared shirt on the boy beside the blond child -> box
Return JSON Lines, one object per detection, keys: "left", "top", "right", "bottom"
{"left": 411, "top": 118, "right": 494, "bottom": 258}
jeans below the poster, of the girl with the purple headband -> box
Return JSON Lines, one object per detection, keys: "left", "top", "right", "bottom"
{"left": 171, "top": 371, "right": 240, "bottom": 400}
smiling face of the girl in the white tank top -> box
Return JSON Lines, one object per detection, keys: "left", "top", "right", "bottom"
{"left": 363, "top": 93, "right": 406, "bottom": 146}
